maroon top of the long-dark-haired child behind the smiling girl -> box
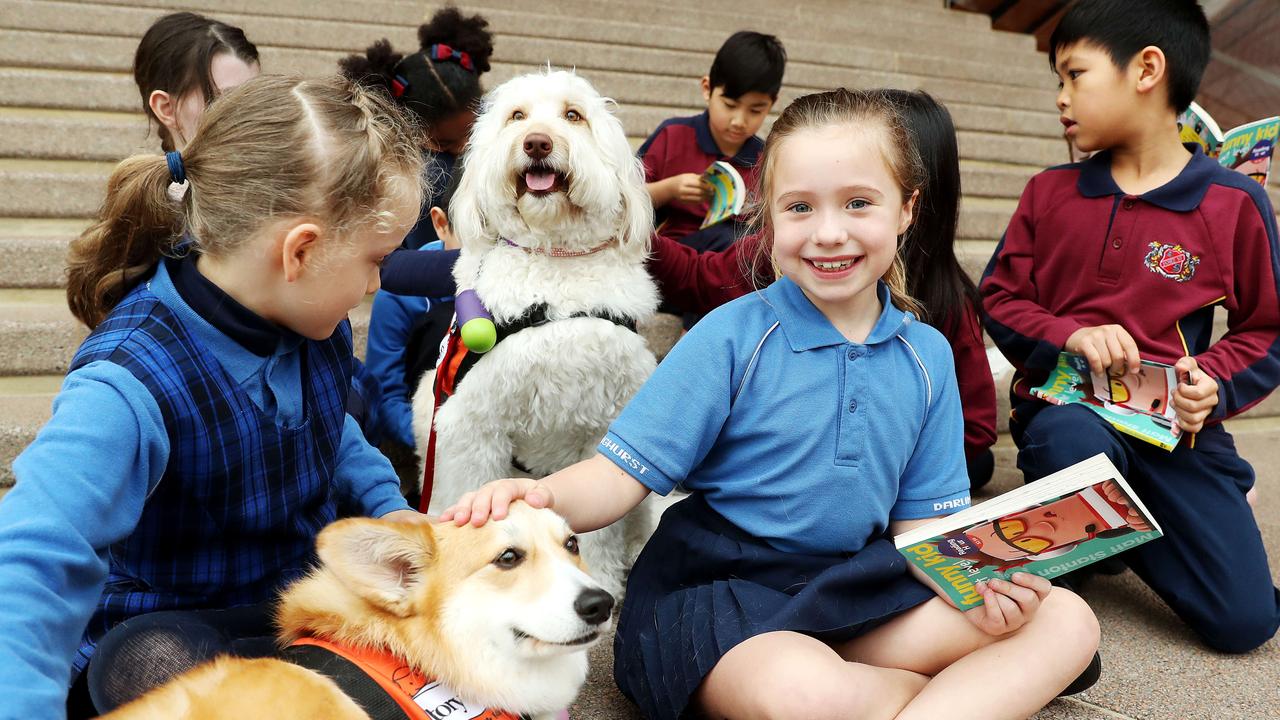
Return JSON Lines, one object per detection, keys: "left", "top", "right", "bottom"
{"left": 649, "top": 234, "right": 996, "bottom": 460}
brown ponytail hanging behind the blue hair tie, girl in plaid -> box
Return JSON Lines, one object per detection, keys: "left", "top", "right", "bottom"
{"left": 67, "top": 155, "right": 182, "bottom": 329}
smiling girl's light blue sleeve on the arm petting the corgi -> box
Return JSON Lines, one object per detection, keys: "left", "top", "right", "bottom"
{"left": 596, "top": 313, "right": 733, "bottom": 495}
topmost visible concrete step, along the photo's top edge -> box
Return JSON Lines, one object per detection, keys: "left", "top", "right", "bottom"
{"left": 22, "top": 0, "right": 1044, "bottom": 73}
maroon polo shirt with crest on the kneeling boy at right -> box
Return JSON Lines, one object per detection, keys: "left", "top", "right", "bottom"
{"left": 980, "top": 146, "right": 1280, "bottom": 421}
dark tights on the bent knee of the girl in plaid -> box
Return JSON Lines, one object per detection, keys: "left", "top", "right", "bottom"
{"left": 84, "top": 603, "right": 276, "bottom": 714}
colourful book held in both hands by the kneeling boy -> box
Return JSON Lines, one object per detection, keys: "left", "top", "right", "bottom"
{"left": 1032, "top": 352, "right": 1183, "bottom": 450}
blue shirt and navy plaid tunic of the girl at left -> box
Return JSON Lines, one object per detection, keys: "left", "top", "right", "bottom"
{"left": 0, "top": 259, "right": 407, "bottom": 717}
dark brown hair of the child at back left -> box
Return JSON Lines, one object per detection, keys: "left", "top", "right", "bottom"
{"left": 133, "top": 13, "right": 257, "bottom": 150}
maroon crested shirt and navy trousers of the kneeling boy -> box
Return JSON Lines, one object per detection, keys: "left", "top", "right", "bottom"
{"left": 980, "top": 145, "right": 1280, "bottom": 652}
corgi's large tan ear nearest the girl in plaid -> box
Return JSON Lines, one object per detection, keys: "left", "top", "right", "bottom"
{"left": 316, "top": 519, "right": 435, "bottom": 618}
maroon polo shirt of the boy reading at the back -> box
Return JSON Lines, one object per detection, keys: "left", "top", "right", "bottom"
{"left": 640, "top": 110, "right": 764, "bottom": 240}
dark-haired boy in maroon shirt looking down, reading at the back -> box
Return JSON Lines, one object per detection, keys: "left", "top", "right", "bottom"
{"left": 640, "top": 31, "right": 787, "bottom": 250}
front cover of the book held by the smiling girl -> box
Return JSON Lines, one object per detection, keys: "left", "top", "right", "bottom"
{"left": 902, "top": 480, "right": 1160, "bottom": 607}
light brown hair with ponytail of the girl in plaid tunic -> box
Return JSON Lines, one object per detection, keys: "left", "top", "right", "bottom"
{"left": 67, "top": 76, "right": 424, "bottom": 328}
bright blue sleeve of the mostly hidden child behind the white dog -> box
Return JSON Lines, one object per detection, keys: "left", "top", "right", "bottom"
{"left": 365, "top": 291, "right": 431, "bottom": 447}
